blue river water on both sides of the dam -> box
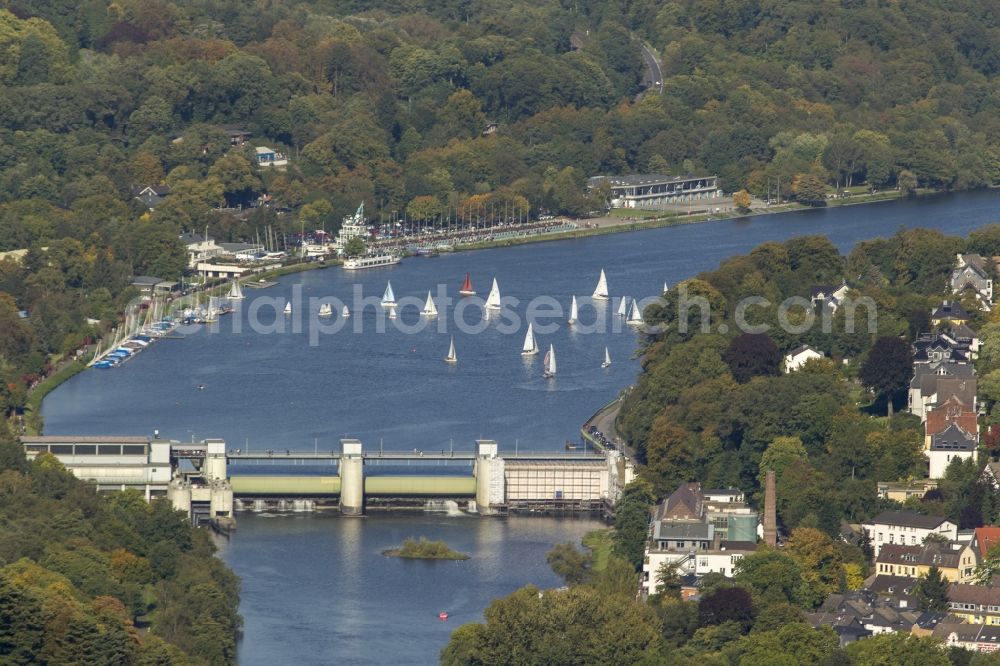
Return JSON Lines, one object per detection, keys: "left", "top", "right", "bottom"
{"left": 42, "top": 191, "right": 1000, "bottom": 664}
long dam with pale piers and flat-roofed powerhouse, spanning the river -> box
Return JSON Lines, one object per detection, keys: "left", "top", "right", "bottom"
{"left": 22, "top": 436, "right": 634, "bottom": 524}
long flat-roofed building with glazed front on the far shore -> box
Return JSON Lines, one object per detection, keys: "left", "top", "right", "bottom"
{"left": 587, "top": 173, "right": 722, "bottom": 210}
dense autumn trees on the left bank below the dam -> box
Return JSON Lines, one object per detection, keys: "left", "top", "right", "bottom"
{"left": 0, "top": 437, "right": 242, "bottom": 666}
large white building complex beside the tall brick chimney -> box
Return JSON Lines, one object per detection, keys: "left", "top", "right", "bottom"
{"left": 642, "top": 483, "right": 759, "bottom": 594}
